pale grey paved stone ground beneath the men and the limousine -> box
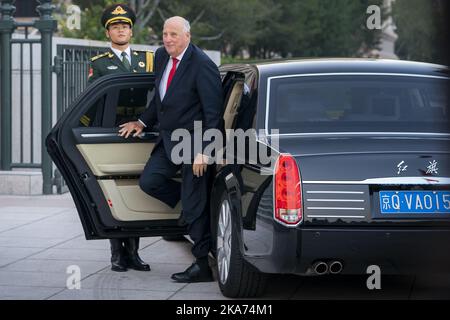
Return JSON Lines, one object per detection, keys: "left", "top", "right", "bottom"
{"left": 0, "top": 194, "right": 450, "bottom": 300}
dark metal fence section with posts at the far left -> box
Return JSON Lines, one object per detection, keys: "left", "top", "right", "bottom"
{"left": 0, "top": 0, "right": 57, "bottom": 194}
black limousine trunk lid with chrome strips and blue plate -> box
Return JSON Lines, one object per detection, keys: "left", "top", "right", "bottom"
{"left": 279, "top": 134, "right": 450, "bottom": 224}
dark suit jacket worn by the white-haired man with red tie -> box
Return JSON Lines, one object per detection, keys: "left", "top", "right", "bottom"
{"left": 140, "top": 44, "right": 223, "bottom": 157}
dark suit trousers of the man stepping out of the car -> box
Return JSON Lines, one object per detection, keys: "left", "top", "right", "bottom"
{"left": 139, "top": 141, "right": 211, "bottom": 258}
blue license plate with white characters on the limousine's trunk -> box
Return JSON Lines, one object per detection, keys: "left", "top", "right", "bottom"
{"left": 380, "top": 191, "right": 450, "bottom": 214}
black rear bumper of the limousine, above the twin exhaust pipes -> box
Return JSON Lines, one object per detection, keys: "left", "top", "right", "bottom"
{"left": 246, "top": 228, "right": 450, "bottom": 275}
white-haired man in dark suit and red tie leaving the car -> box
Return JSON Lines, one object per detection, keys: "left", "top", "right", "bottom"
{"left": 119, "top": 17, "right": 223, "bottom": 282}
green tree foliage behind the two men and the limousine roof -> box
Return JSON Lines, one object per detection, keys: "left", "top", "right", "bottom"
{"left": 57, "top": 0, "right": 383, "bottom": 59}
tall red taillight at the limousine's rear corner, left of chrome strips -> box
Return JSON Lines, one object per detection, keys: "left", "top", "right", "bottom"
{"left": 275, "top": 154, "right": 303, "bottom": 225}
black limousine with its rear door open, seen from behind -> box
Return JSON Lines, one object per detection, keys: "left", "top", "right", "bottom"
{"left": 47, "top": 59, "right": 450, "bottom": 297}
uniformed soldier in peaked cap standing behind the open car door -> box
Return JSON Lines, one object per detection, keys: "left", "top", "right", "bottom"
{"left": 86, "top": 4, "right": 153, "bottom": 271}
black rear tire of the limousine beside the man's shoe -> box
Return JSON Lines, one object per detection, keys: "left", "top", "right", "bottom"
{"left": 214, "top": 191, "right": 267, "bottom": 298}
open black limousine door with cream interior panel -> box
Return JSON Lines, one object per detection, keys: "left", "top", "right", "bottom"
{"left": 46, "top": 73, "right": 187, "bottom": 239}
